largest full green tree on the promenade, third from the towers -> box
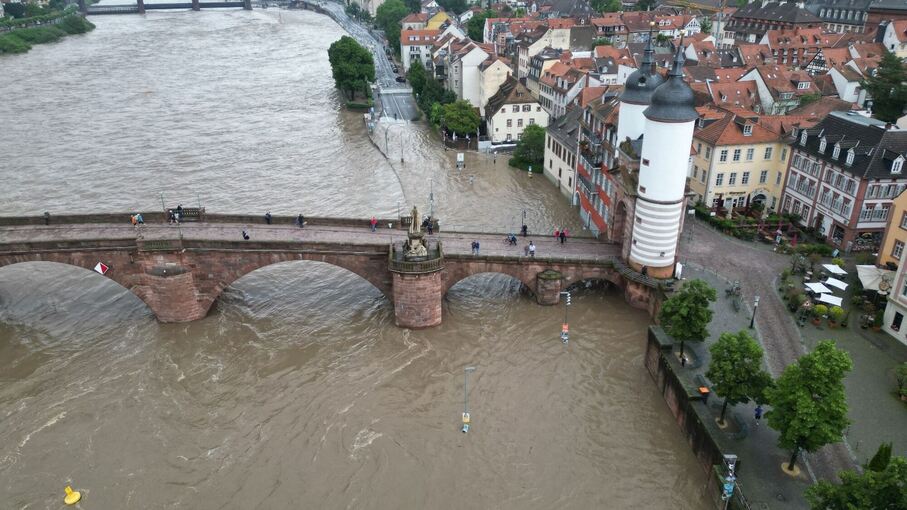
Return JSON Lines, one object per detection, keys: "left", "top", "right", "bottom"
{"left": 765, "top": 340, "right": 853, "bottom": 470}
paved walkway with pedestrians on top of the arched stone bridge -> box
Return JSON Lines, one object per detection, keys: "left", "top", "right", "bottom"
{"left": 0, "top": 223, "right": 620, "bottom": 260}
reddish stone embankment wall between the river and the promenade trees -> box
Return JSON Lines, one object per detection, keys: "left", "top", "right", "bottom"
{"left": 644, "top": 325, "right": 749, "bottom": 509}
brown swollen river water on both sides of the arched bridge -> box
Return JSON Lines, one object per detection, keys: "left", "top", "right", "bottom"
{"left": 0, "top": 9, "right": 708, "bottom": 510}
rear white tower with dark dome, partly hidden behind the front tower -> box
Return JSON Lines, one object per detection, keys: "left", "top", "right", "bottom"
{"left": 617, "top": 22, "right": 665, "bottom": 145}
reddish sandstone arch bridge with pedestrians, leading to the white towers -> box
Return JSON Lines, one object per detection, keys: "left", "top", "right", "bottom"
{"left": 0, "top": 213, "right": 670, "bottom": 328}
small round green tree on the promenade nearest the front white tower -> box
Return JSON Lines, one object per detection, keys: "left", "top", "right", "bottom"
{"left": 658, "top": 280, "right": 717, "bottom": 356}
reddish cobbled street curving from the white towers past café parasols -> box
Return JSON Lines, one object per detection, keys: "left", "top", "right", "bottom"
{"left": 680, "top": 220, "right": 856, "bottom": 480}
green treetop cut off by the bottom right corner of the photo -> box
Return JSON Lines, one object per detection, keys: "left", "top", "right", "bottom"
{"left": 806, "top": 457, "right": 907, "bottom": 510}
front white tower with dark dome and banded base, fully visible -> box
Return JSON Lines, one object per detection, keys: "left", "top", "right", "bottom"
{"left": 621, "top": 44, "right": 699, "bottom": 278}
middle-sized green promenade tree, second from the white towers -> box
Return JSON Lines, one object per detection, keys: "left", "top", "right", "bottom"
{"left": 705, "top": 331, "right": 771, "bottom": 423}
